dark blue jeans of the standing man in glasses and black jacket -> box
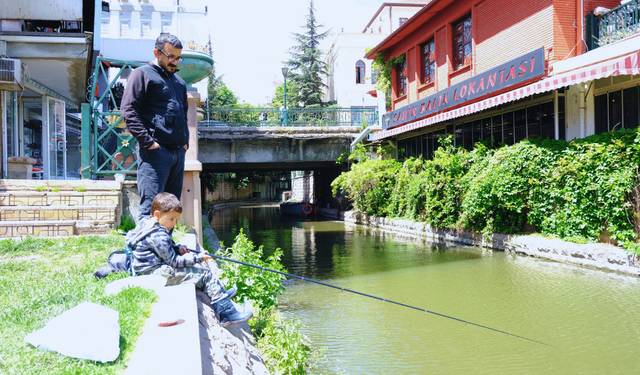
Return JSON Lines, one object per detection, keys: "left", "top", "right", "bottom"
{"left": 138, "top": 146, "right": 186, "bottom": 221}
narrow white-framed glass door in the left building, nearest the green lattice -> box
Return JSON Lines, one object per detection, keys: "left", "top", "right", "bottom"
{"left": 45, "top": 97, "right": 67, "bottom": 180}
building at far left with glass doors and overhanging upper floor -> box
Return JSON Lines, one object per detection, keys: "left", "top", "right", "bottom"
{"left": 0, "top": 0, "right": 101, "bottom": 179}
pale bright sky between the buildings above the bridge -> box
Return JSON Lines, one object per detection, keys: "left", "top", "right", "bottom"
{"left": 181, "top": 0, "right": 384, "bottom": 105}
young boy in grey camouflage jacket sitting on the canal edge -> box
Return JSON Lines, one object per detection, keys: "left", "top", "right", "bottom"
{"left": 125, "top": 193, "right": 253, "bottom": 327}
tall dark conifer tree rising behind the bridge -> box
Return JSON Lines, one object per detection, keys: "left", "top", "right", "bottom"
{"left": 285, "top": 0, "right": 331, "bottom": 107}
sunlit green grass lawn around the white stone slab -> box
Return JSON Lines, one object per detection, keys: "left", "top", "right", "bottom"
{"left": 0, "top": 234, "right": 157, "bottom": 375}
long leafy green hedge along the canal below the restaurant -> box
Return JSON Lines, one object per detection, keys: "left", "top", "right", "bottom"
{"left": 332, "top": 129, "right": 640, "bottom": 254}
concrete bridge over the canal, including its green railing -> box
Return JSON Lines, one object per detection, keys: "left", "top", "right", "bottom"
{"left": 198, "top": 108, "right": 376, "bottom": 172}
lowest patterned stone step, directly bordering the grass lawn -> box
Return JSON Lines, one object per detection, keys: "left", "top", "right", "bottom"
{"left": 0, "top": 220, "right": 113, "bottom": 238}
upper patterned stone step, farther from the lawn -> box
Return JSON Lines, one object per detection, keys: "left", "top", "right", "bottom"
{"left": 0, "top": 192, "right": 121, "bottom": 206}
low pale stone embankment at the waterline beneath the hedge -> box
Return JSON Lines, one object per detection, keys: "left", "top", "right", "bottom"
{"left": 340, "top": 211, "right": 640, "bottom": 276}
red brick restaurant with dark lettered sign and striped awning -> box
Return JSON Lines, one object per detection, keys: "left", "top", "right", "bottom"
{"left": 366, "top": 0, "right": 640, "bottom": 157}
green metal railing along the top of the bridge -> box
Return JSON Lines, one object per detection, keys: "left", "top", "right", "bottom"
{"left": 198, "top": 107, "right": 378, "bottom": 127}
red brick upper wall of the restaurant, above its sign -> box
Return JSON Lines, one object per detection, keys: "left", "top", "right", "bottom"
{"left": 384, "top": 0, "right": 580, "bottom": 109}
